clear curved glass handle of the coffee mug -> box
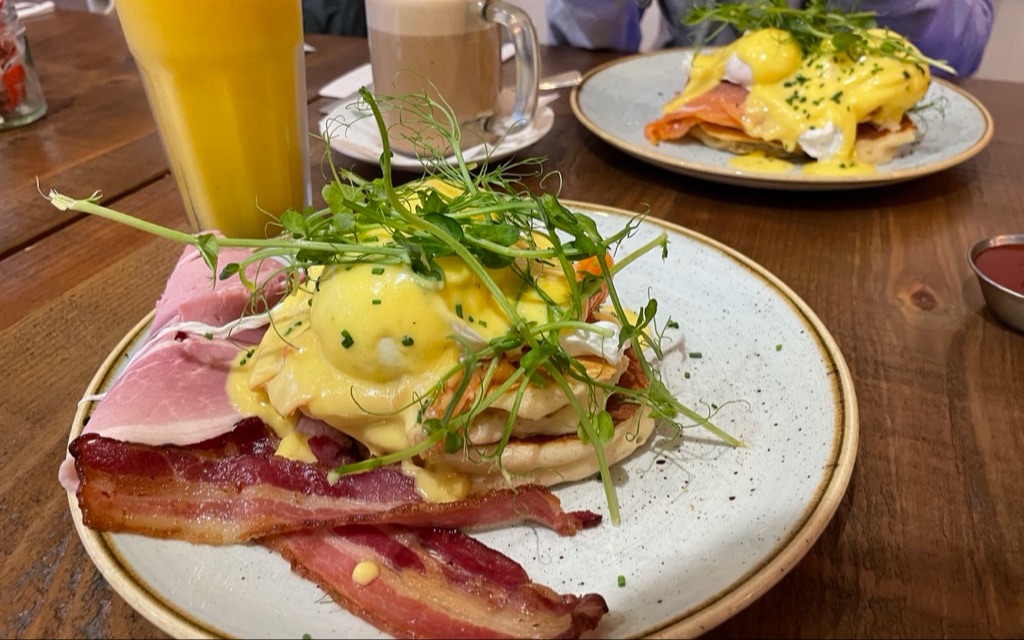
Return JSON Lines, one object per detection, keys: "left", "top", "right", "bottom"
{"left": 483, "top": 0, "right": 541, "bottom": 131}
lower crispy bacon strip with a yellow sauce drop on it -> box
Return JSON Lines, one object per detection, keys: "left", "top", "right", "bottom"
{"left": 262, "top": 525, "right": 608, "bottom": 638}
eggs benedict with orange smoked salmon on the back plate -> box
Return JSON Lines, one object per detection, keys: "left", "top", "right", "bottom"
{"left": 644, "top": 22, "right": 931, "bottom": 172}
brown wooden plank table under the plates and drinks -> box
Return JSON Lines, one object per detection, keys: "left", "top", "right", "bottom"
{"left": 0, "top": 11, "right": 1024, "bottom": 638}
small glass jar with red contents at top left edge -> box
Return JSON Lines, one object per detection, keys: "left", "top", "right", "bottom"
{"left": 0, "top": 0, "right": 46, "bottom": 131}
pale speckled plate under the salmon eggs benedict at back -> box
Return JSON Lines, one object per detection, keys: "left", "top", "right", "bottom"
{"left": 571, "top": 49, "right": 992, "bottom": 190}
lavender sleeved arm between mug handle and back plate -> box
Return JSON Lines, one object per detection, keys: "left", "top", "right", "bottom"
{"left": 545, "top": 0, "right": 647, "bottom": 51}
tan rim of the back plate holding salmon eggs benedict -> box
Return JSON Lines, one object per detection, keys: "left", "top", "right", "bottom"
{"left": 569, "top": 47, "right": 994, "bottom": 190}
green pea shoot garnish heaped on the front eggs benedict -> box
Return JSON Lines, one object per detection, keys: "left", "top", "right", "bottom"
{"left": 49, "top": 89, "right": 740, "bottom": 522}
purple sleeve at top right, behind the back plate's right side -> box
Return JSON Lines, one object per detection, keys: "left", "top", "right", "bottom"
{"left": 859, "top": 0, "right": 992, "bottom": 76}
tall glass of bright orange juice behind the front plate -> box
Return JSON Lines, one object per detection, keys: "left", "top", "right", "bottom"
{"left": 117, "top": 0, "right": 311, "bottom": 238}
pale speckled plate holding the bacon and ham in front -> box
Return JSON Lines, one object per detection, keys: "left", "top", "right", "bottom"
{"left": 70, "top": 203, "right": 858, "bottom": 638}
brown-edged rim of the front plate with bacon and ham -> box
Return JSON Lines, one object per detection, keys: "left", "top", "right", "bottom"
{"left": 67, "top": 200, "right": 859, "bottom": 639}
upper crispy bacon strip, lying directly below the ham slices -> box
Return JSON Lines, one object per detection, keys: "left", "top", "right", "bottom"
{"left": 71, "top": 419, "right": 601, "bottom": 545}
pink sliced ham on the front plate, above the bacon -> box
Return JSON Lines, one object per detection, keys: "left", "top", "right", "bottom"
{"left": 57, "top": 241, "right": 285, "bottom": 493}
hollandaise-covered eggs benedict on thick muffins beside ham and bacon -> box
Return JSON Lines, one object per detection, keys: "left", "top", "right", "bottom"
{"left": 218, "top": 179, "right": 654, "bottom": 502}
